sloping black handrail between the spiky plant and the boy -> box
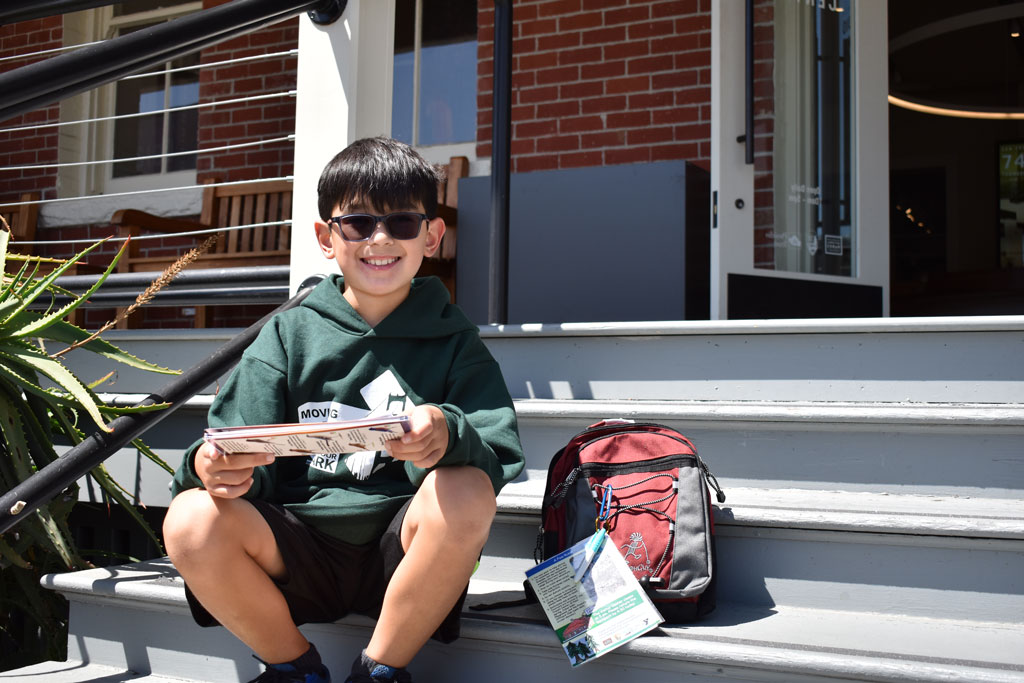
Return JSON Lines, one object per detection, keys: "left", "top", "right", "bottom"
{"left": 0, "top": 279, "right": 318, "bottom": 533}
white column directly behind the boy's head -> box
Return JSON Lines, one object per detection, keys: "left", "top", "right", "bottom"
{"left": 289, "top": 0, "right": 394, "bottom": 293}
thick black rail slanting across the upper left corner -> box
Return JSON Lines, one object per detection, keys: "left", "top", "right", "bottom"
{"left": 0, "top": 0, "right": 324, "bottom": 121}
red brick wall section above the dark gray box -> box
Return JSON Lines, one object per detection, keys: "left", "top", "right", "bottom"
{"left": 477, "top": 0, "right": 711, "bottom": 172}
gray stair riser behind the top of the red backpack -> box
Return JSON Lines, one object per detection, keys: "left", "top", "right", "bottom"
{"left": 519, "top": 415, "right": 1024, "bottom": 498}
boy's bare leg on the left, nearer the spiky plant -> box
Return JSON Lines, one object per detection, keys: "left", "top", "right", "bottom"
{"left": 164, "top": 488, "right": 309, "bottom": 664}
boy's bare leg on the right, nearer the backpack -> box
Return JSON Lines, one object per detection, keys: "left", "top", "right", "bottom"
{"left": 367, "top": 467, "right": 495, "bottom": 668}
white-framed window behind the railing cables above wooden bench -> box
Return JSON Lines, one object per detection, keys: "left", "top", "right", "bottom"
{"left": 108, "top": 0, "right": 202, "bottom": 185}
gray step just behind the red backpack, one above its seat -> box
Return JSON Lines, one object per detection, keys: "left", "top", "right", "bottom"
{"left": 484, "top": 484, "right": 1024, "bottom": 623}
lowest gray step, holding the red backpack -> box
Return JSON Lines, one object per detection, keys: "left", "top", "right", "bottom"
{"left": 8, "top": 560, "right": 1024, "bottom": 683}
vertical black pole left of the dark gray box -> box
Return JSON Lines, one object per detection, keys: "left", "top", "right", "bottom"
{"left": 487, "top": 0, "right": 512, "bottom": 325}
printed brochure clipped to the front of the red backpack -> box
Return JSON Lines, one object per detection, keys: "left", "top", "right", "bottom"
{"left": 526, "top": 531, "right": 665, "bottom": 667}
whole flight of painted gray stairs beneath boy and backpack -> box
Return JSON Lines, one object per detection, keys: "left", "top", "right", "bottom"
{"left": 9, "top": 316, "right": 1024, "bottom": 681}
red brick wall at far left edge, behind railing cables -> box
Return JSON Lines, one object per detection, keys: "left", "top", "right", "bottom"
{"left": 0, "top": 16, "right": 63, "bottom": 202}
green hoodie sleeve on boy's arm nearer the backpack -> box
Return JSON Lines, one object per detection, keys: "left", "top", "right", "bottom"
{"left": 406, "top": 337, "right": 525, "bottom": 494}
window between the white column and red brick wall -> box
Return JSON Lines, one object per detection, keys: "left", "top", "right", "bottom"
{"left": 391, "top": 0, "right": 477, "bottom": 146}
